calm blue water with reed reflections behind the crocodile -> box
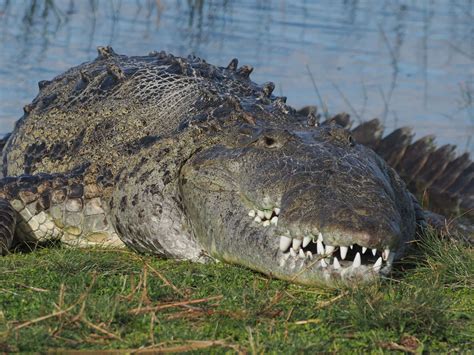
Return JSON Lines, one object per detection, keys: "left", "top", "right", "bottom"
{"left": 0, "top": 0, "right": 474, "bottom": 153}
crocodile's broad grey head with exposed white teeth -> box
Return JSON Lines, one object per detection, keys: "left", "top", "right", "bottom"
{"left": 180, "top": 122, "right": 415, "bottom": 285}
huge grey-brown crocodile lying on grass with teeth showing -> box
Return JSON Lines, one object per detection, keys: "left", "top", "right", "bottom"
{"left": 0, "top": 47, "right": 473, "bottom": 286}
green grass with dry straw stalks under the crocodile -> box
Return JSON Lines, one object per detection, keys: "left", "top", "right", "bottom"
{"left": 0, "top": 235, "right": 474, "bottom": 353}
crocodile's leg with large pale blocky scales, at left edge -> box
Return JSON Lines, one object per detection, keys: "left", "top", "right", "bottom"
{"left": 0, "top": 167, "right": 123, "bottom": 253}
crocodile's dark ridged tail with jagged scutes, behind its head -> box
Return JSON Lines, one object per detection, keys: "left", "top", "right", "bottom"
{"left": 346, "top": 119, "right": 474, "bottom": 217}
